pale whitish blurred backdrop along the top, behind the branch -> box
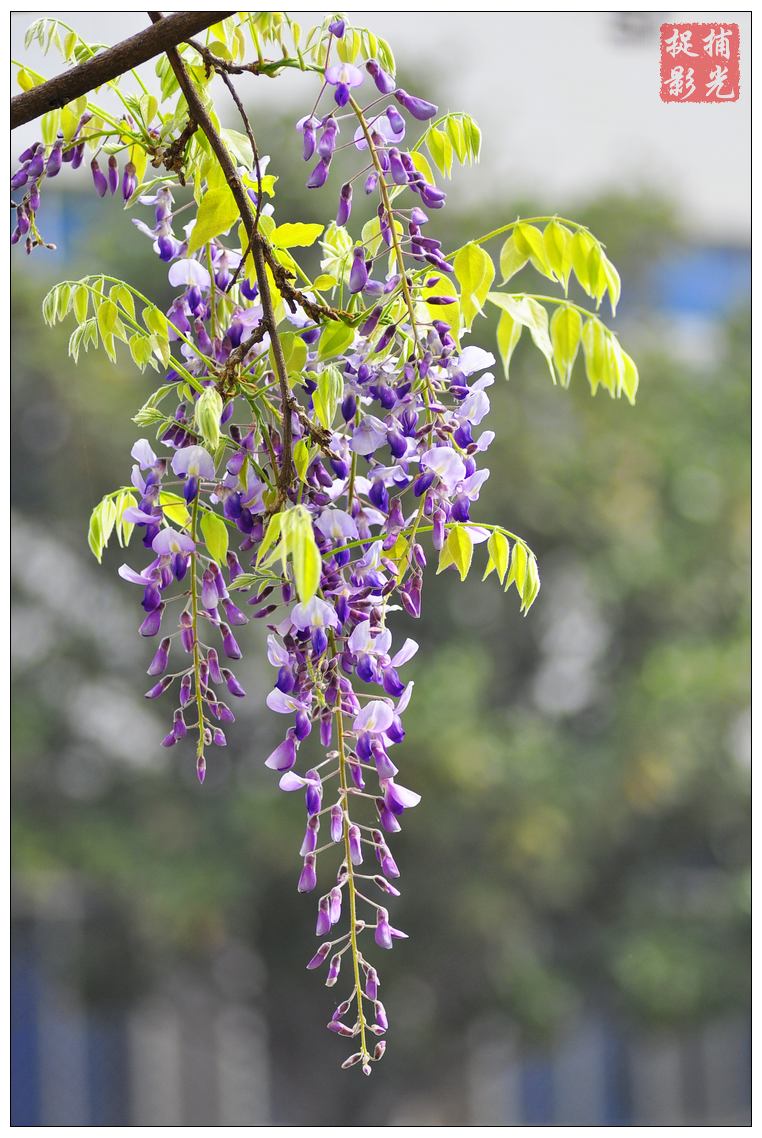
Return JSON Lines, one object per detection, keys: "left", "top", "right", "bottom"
{"left": 11, "top": 11, "right": 751, "bottom": 241}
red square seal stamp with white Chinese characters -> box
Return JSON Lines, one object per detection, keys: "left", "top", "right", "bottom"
{"left": 660, "top": 23, "right": 740, "bottom": 102}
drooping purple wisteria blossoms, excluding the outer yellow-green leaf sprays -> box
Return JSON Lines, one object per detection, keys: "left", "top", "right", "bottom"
{"left": 11, "top": 18, "right": 636, "bottom": 1074}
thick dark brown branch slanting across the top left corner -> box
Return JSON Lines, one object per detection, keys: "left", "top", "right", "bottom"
{"left": 10, "top": 11, "right": 234, "bottom": 130}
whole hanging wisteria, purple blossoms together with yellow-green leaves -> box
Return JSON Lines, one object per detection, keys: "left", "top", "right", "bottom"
{"left": 11, "top": 13, "right": 637, "bottom": 1074}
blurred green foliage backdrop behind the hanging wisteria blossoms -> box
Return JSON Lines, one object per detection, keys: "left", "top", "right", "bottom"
{"left": 11, "top": 60, "right": 749, "bottom": 1124}
